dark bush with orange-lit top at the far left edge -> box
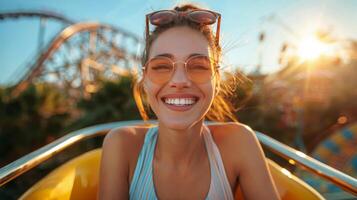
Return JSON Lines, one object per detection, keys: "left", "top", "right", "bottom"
{"left": 0, "top": 84, "right": 69, "bottom": 165}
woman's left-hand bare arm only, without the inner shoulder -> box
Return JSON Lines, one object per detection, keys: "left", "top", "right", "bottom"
{"left": 98, "top": 128, "right": 132, "bottom": 200}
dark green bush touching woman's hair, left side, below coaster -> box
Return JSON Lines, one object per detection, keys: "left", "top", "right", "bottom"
{"left": 70, "top": 76, "right": 140, "bottom": 130}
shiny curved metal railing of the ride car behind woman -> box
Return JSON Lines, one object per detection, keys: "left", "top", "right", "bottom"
{"left": 0, "top": 120, "right": 357, "bottom": 195}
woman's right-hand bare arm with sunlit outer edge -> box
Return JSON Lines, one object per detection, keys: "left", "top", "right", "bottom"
{"left": 227, "top": 124, "right": 280, "bottom": 200}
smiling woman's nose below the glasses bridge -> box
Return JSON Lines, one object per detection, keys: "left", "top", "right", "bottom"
{"left": 169, "top": 62, "right": 191, "bottom": 88}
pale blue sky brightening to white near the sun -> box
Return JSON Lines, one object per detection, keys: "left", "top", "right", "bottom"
{"left": 0, "top": 0, "right": 357, "bottom": 85}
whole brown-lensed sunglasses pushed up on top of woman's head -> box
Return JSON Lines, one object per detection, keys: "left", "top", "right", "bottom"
{"left": 146, "top": 9, "right": 221, "bottom": 46}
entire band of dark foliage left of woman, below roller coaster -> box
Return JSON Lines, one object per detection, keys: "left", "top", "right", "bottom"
{"left": 0, "top": 77, "right": 140, "bottom": 165}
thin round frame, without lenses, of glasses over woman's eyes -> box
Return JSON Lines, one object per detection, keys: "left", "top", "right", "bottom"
{"left": 142, "top": 55, "right": 218, "bottom": 84}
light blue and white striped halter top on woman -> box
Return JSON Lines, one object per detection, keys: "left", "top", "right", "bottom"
{"left": 129, "top": 127, "right": 234, "bottom": 200}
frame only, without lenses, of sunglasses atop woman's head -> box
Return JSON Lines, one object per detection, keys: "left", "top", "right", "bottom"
{"left": 145, "top": 9, "right": 221, "bottom": 46}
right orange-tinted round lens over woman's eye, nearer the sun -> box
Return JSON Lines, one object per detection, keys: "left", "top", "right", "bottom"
{"left": 186, "top": 56, "right": 213, "bottom": 83}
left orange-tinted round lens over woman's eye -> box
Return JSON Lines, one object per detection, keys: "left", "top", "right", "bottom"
{"left": 146, "top": 57, "right": 173, "bottom": 84}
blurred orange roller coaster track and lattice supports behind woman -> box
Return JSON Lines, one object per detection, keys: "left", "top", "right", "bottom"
{"left": 0, "top": 11, "right": 142, "bottom": 96}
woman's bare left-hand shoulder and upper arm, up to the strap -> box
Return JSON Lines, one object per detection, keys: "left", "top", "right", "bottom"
{"left": 98, "top": 127, "right": 147, "bottom": 199}
